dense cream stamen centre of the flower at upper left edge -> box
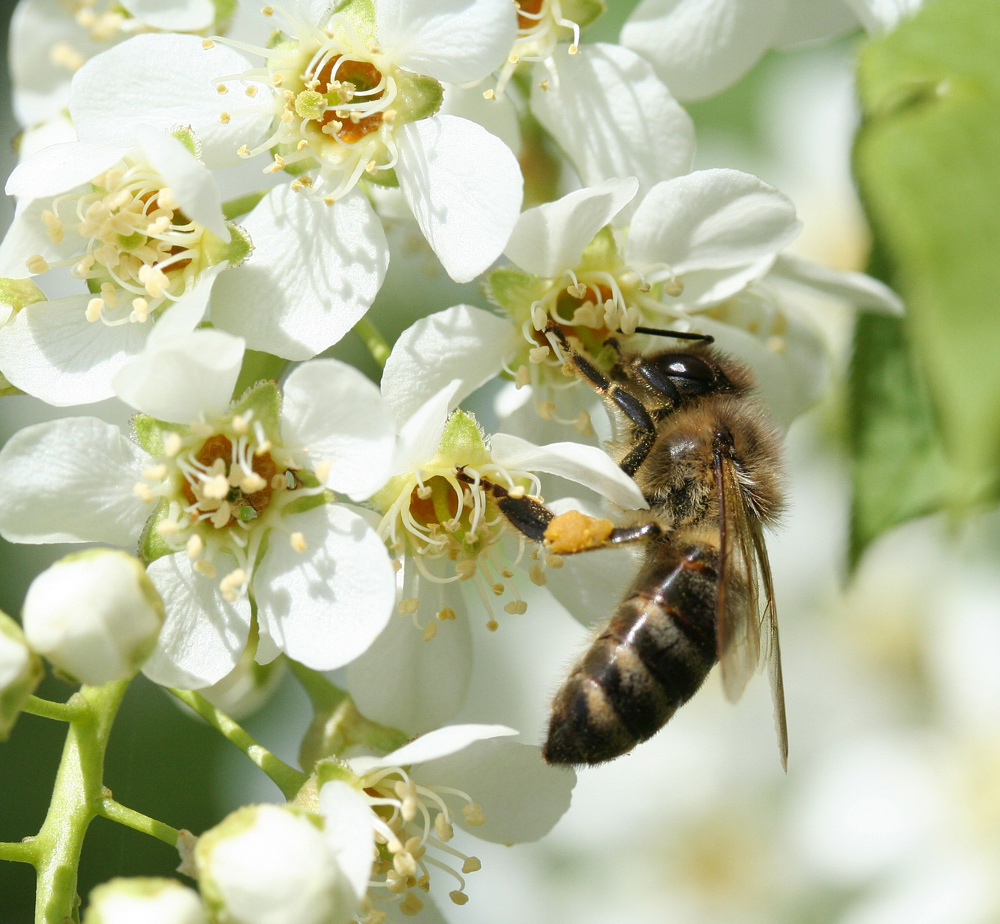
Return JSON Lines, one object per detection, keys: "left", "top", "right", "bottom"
{"left": 28, "top": 157, "right": 218, "bottom": 326}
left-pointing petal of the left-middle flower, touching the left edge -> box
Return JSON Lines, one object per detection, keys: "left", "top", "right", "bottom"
{"left": 0, "top": 417, "right": 152, "bottom": 549}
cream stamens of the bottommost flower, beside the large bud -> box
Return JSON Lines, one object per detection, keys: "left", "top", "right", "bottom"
{"left": 359, "top": 767, "right": 486, "bottom": 924}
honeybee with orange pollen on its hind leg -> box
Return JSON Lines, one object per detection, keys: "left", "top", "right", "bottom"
{"left": 484, "top": 325, "right": 788, "bottom": 767}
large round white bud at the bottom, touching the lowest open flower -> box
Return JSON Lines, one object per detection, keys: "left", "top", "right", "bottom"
{"left": 195, "top": 805, "right": 358, "bottom": 924}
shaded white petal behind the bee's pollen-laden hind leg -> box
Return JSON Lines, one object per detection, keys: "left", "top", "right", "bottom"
{"left": 545, "top": 497, "right": 644, "bottom": 628}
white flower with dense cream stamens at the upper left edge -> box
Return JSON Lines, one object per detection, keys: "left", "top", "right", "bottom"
{"left": 0, "top": 126, "right": 249, "bottom": 405}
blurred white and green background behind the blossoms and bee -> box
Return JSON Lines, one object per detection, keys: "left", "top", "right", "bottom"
{"left": 0, "top": 1, "right": 1000, "bottom": 924}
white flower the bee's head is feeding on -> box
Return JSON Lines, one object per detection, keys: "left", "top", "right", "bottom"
{"left": 486, "top": 170, "right": 901, "bottom": 432}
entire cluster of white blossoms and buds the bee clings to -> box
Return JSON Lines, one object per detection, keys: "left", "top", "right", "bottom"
{"left": 0, "top": 0, "right": 915, "bottom": 924}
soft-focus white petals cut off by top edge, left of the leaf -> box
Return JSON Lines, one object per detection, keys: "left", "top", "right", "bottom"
{"left": 621, "top": 0, "right": 923, "bottom": 99}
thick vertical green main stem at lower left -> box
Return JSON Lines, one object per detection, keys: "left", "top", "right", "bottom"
{"left": 31, "top": 680, "right": 129, "bottom": 924}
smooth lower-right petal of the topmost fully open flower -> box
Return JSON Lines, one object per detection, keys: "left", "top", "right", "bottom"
{"left": 396, "top": 115, "right": 524, "bottom": 282}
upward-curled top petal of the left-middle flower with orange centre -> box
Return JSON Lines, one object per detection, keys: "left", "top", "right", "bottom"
{"left": 115, "top": 330, "right": 244, "bottom": 424}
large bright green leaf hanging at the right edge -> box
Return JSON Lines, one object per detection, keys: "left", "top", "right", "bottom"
{"left": 855, "top": 0, "right": 1000, "bottom": 512}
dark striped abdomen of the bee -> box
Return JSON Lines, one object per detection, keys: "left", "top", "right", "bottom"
{"left": 543, "top": 543, "right": 719, "bottom": 764}
